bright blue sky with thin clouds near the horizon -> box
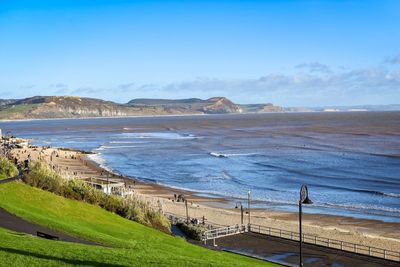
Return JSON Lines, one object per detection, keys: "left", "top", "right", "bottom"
{"left": 0, "top": 0, "right": 400, "bottom": 106}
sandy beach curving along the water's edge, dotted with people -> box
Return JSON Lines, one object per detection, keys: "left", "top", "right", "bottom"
{"left": 11, "top": 144, "right": 400, "bottom": 255}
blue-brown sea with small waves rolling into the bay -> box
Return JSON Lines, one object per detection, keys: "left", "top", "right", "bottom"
{"left": 0, "top": 112, "right": 400, "bottom": 222}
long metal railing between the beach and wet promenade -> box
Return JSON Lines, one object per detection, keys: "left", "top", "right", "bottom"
{"left": 249, "top": 224, "right": 400, "bottom": 261}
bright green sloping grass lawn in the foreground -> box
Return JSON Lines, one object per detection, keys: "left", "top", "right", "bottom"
{"left": 0, "top": 182, "right": 273, "bottom": 266}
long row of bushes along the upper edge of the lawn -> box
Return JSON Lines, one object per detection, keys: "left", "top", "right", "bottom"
{"left": 24, "top": 162, "right": 171, "bottom": 233}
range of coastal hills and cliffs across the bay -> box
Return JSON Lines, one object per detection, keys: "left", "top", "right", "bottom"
{"left": 0, "top": 96, "right": 283, "bottom": 119}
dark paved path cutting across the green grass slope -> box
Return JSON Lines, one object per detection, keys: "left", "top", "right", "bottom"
{"left": 0, "top": 208, "right": 98, "bottom": 245}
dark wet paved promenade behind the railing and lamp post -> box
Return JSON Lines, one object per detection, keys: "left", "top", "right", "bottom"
{"left": 208, "top": 233, "right": 400, "bottom": 267}
